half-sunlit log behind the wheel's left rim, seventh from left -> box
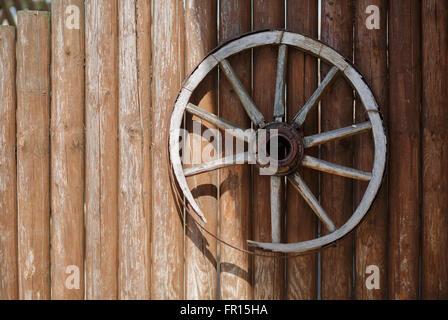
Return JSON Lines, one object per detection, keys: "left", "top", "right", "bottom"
{"left": 185, "top": 0, "right": 218, "bottom": 300}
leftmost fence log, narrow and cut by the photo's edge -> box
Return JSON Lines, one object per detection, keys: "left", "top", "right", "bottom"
{"left": 0, "top": 26, "right": 18, "bottom": 300}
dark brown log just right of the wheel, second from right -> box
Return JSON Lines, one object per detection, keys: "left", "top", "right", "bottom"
{"left": 388, "top": 0, "right": 421, "bottom": 299}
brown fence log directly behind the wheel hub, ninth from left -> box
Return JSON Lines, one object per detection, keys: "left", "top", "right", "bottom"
{"left": 252, "top": 0, "right": 285, "bottom": 300}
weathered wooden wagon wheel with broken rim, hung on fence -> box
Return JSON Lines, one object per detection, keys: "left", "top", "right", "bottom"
{"left": 169, "top": 31, "right": 387, "bottom": 253}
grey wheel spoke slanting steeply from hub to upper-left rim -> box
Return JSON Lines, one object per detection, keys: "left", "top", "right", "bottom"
{"left": 220, "top": 59, "right": 265, "bottom": 127}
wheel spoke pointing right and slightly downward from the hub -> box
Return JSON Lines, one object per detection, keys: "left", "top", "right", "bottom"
{"left": 302, "top": 156, "right": 372, "bottom": 181}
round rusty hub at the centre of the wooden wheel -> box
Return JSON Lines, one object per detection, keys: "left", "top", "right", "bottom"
{"left": 257, "top": 122, "right": 304, "bottom": 176}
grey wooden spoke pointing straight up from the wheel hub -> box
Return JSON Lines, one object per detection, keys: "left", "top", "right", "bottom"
{"left": 274, "top": 44, "right": 288, "bottom": 119}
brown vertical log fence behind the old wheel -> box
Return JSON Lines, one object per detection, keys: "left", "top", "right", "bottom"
{"left": 0, "top": 0, "right": 448, "bottom": 299}
